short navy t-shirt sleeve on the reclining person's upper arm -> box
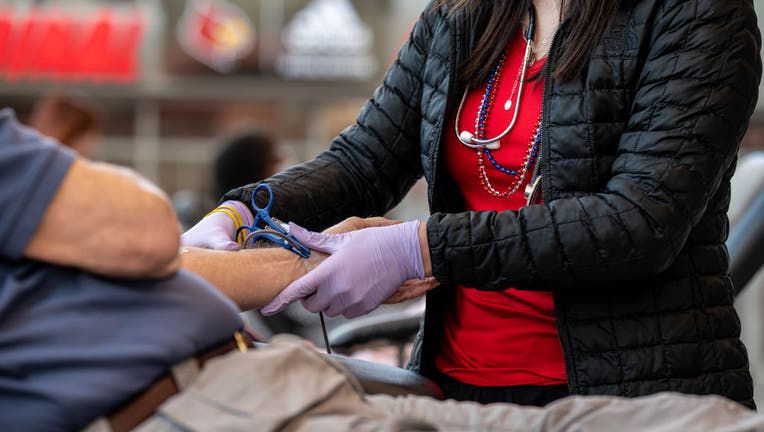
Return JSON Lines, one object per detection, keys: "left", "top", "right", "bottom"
{"left": 0, "top": 109, "right": 76, "bottom": 260}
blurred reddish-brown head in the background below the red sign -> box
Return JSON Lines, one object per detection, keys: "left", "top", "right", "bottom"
{"left": 29, "top": 94, "right": 102, "bottom": 156}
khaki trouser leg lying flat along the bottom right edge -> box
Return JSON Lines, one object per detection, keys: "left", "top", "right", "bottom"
{"left": 368, "top": 392, "right": 764, "bottom": 432}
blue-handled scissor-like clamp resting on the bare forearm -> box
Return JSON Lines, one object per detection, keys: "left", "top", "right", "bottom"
{"left": 236, "top": 183, "right": 310, "bottom": 258}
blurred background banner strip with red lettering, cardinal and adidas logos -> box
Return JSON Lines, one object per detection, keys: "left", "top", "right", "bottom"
{"left": 0, "top": 0, "right": 380, "bottom": 85}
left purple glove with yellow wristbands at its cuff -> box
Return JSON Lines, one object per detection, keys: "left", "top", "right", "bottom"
{"left": 180, "top": 201, "right": 252, "bottom": 251}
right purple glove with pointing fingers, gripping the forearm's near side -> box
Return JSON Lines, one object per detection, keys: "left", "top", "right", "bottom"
{"left": 261, "top": 221, "right": 425, "bottom": 318}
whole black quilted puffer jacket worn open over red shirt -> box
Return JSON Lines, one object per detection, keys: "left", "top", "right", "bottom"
{"left": 225, "top": 0, "right": 761, "bottom": 407}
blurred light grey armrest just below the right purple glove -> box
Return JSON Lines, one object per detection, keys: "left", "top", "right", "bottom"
{"left": 329, "top": 310, "right": 422, "bottom": 349}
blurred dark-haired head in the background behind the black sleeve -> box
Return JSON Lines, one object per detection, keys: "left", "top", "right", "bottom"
{"left": 213, "top": 131, "right": 281, "bottom": 199}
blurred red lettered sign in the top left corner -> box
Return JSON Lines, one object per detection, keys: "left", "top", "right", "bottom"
{"left": 0, "top": 7, "right": 144, "bottom": 83}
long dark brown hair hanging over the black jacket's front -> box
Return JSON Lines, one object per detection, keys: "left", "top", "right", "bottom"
{"left": 439, "top": 0, "right": 621, "bottom": 86}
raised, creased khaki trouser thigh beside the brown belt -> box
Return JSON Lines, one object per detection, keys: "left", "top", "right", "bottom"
{"left": 138, "top": 336, "right": 426, "bottom": 432}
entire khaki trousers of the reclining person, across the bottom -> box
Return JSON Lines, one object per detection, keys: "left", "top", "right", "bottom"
{"left": 138, "top": 336, "right": 764, "bottom": 432}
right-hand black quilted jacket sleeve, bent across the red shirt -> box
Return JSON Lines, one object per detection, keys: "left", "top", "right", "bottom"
{"left": 428, "top": 0, "right": 761, "bottom": 290}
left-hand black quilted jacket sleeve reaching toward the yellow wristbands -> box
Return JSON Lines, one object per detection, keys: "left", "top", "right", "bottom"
{"left": 221, "top": 6, "right": 440, "bottom": 230}
